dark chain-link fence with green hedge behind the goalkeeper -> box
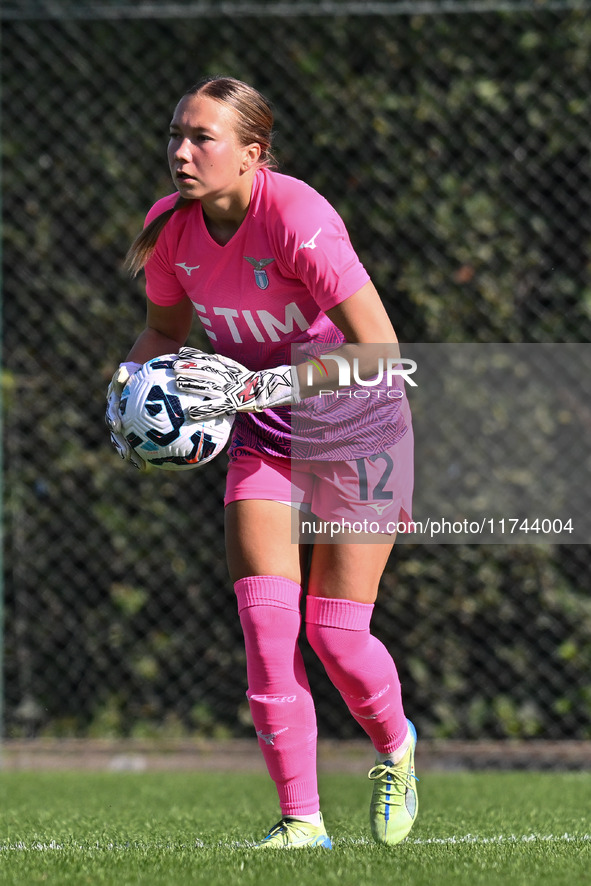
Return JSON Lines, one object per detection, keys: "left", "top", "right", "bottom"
{"left": 2, "top": 0, "right": 591, "bottom": 739}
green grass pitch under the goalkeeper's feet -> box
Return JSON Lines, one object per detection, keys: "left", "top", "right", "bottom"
{"left": 0, "top": 770, "right": 591, "bottom": 886}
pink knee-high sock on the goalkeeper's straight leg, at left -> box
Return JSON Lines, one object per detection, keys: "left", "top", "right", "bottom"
{"left": 234, "top": 575, "right": 319, "bottom": 816}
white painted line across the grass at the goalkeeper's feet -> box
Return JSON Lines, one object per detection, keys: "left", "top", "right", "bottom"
{"left": 0, "top": 834, "right": 591, "bottom": 853}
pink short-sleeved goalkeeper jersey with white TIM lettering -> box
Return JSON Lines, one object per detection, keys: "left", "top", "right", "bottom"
{"left": 145, "top": 169, "right": 410, "bottom": 458}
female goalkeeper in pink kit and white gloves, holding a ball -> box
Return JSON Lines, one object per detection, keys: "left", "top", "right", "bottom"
{"left": 107, "top": 77, "right": 417, "bottom": 849}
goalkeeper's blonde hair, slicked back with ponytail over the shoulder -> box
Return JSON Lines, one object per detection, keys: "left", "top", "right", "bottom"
{"left": 125, "top": 77, "right": 276, "bottom": 277}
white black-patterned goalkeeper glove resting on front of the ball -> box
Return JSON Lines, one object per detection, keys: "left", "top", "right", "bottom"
{"left": 173, "top": 348, "right": 299, "bottom": 420}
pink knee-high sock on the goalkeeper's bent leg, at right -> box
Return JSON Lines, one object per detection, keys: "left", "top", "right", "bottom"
{"left": 306, "top": 597, "right": 408, "bottom": 754}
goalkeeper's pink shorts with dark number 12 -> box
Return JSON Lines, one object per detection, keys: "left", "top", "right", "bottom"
{"left": 224, "top": 429, "right": 413, "bottom": 534}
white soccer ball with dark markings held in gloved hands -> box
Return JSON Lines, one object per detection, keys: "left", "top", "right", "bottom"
{"left": 119, "top": 354, "right": 234, "bottom": 471}
